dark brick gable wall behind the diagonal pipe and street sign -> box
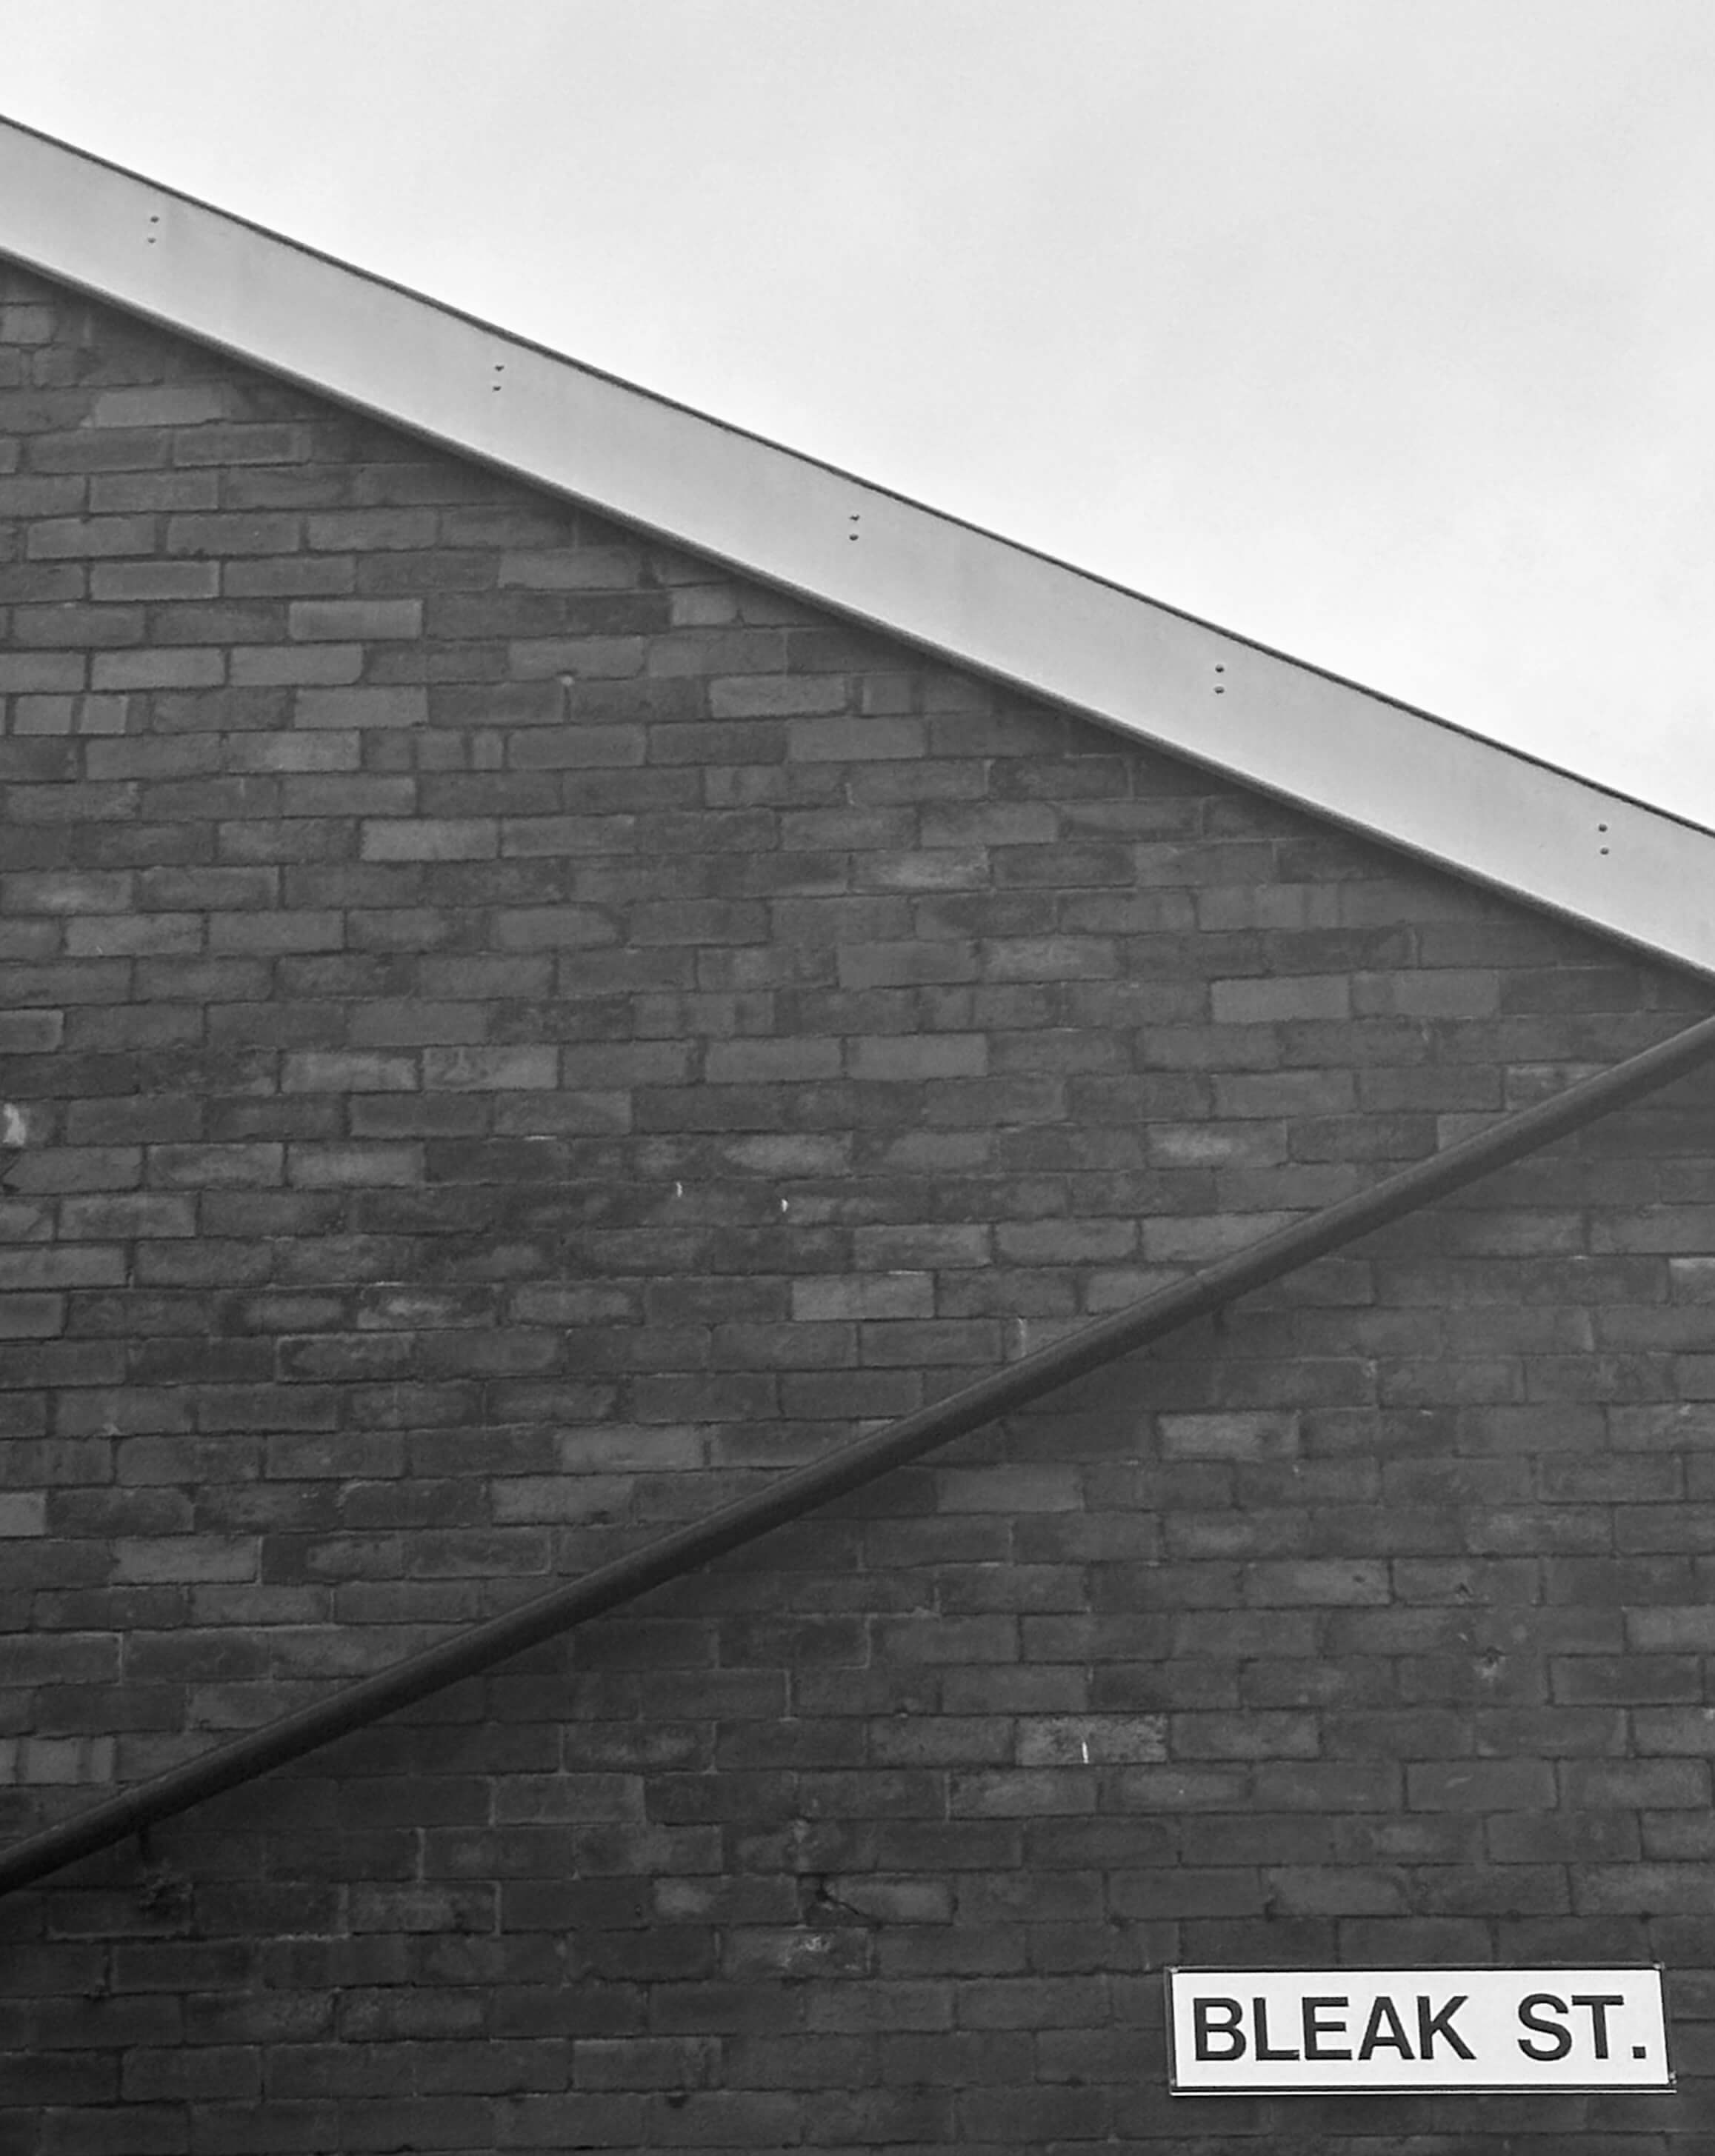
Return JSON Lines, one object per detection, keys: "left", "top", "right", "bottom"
{"left": 0, "top": 261, "right": 1715, "bottom": 2156}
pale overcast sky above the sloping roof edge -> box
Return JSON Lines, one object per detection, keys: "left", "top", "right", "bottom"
{"left": 0, "top": 0, "right": 1715, "bottom": 824}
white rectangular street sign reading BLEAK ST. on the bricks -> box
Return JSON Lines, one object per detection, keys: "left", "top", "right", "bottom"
{"left": 1167, "top": 1969, "right": 1674, "bottom": 2095}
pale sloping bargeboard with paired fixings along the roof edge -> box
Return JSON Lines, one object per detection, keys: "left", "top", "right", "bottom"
{"left": 0, "top": 107, "right": 1715, "bottom": 972}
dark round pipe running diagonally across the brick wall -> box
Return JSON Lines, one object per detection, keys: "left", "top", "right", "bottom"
{"left": 0, "top": 1000, "right": 1715, "bottom": 1893}
